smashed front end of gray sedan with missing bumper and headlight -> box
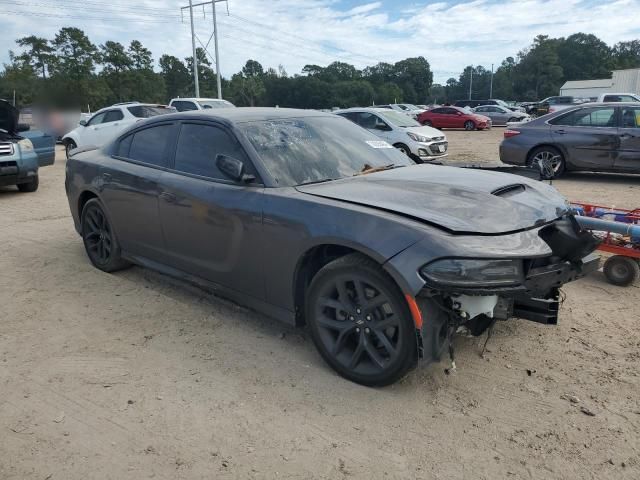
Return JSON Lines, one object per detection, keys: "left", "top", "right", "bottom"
{"left": 408, "top": 215, "right": 599, "bottom": 365}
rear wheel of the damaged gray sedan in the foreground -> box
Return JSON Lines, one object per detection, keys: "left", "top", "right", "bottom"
{"left": 81, "top": 198, "right": 129, "bottom": 272}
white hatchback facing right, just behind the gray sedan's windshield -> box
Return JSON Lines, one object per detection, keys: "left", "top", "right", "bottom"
{"left": 333, "top": 108, "right": 449, "bottom": 163}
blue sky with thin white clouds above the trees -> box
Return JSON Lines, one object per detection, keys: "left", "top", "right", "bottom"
{"left": 0, "top": 0, "right": 640, "bottom": 82}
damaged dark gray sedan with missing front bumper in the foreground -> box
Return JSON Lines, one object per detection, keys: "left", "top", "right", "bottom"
{"left": 65, "top": 108, "right": 597, "bottom": 385}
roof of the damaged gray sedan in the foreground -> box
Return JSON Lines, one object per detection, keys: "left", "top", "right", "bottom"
{"left": 139, "top": 107, "right": 336, "bottom": 125}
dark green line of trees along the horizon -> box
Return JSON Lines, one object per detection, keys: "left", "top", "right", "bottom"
{"left": 0, "top": 27, "right": 640, "bottom": 110}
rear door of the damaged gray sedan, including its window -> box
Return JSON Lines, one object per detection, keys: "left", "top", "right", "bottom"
{"left": 98, "top": 122, "right": 176, "bottom": 261}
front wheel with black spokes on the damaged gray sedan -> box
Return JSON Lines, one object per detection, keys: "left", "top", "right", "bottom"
{"left": 305, "top": 254, "right": 418, "bottom": 387}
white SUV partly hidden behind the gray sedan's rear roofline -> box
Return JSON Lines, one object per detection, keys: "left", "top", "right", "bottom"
{"left": 62, "top": 102, "right": 176, "bottom": 158}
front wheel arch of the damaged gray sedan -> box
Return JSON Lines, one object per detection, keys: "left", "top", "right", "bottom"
{"left": 292, "top": 240, "right": 410, "bottom": 326}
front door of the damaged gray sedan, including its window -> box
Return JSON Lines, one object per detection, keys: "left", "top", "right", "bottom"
{"left": 160, "top": 121, "right": 264, "bottom": 299}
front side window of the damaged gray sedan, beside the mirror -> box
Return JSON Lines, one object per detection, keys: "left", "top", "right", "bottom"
{"left": 175, "top": 123, "right": 251, "bottom": 180}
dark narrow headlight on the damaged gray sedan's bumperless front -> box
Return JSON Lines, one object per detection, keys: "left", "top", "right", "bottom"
{"left": 420, "top": 258, "right": 523, "bottom": 287}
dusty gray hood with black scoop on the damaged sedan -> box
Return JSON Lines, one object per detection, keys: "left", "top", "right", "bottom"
{"left": 296, "top": 165, "right": 568, "bottom": 235}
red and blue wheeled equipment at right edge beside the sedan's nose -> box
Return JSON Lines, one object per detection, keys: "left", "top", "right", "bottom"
{"left": 572, "top": 202, "right": 640, "bottom": 286}
